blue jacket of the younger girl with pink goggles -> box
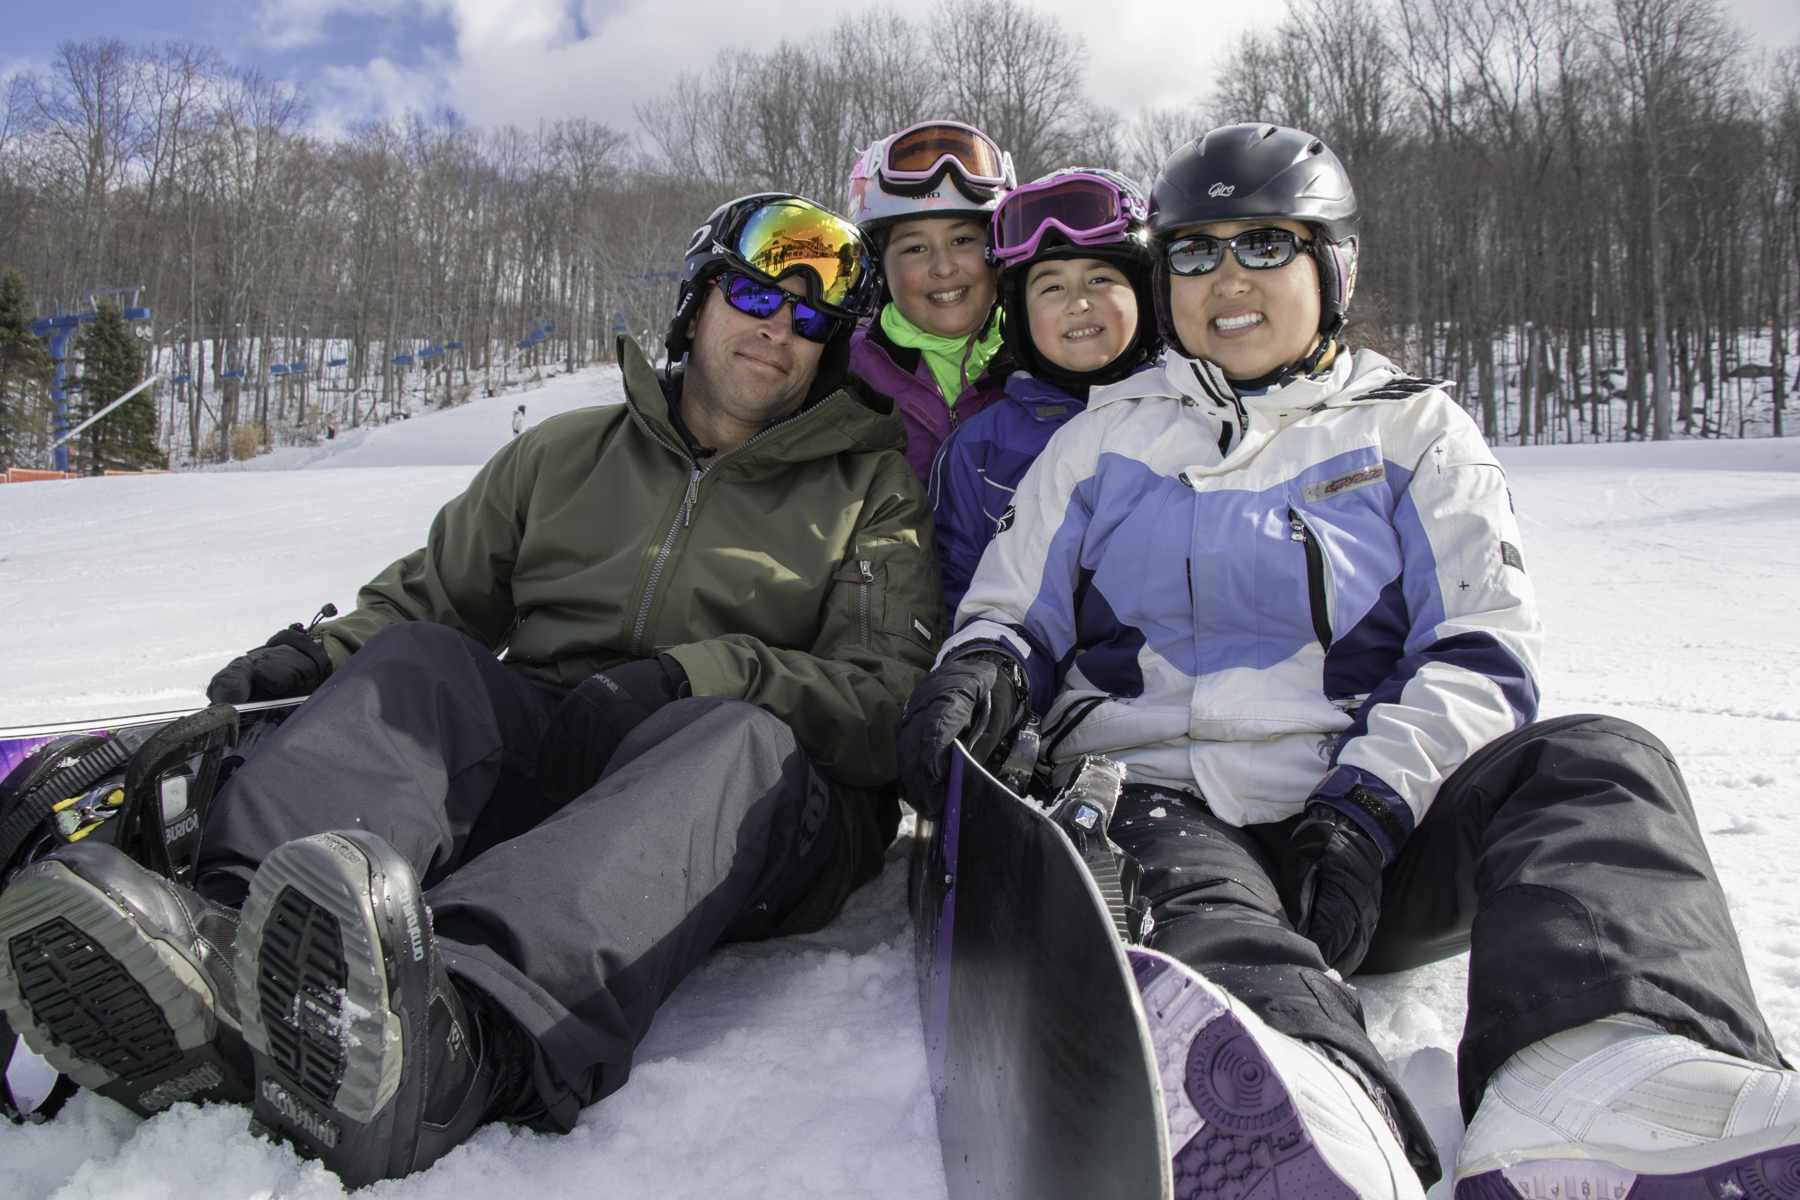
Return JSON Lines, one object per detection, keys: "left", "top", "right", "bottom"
{"left": 925, "top": 371, "right": 1087, "bottom": 617}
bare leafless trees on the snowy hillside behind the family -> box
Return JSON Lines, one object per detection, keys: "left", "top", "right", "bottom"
{"left": 0, "top": 0, "right": 1800, "bottom": 466}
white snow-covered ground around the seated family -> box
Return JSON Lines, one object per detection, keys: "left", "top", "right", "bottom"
{"left": 0, "top": 369, "right": 1800, "bottom": 1200}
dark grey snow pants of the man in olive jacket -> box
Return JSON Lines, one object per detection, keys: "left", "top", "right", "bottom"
{"left": 200, "top": 622, "right": 846, "bottom": 1130}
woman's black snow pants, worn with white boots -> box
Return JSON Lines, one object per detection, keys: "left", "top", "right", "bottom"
{"left": 1111, "top": 716, "right": 1782, "bottom": 1171}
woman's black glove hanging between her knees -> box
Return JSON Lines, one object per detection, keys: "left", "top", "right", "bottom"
{"left": 1282, "top": 801, "right": 1382, "bottom": 975}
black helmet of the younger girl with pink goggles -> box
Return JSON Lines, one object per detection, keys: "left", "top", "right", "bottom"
{"left": 990, "top": 167, "right": 1163, "bottom": 394}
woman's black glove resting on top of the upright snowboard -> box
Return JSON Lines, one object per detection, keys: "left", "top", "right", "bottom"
{"left": 895, "top": 651, "right": 1026, "bottom": 817}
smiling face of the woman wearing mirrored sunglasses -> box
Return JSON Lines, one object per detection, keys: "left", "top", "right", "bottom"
{"left": 1168, "top": 218, "right": 1319, "bottom": 380}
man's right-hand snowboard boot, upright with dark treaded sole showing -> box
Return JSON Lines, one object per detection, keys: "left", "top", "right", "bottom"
{"left": 238, "top": 829, "right": 497, "bottom": 1187}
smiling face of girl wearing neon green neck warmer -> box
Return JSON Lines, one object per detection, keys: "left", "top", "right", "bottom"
{"left": 882, "top": 216, "right": 999, "bottom": 338}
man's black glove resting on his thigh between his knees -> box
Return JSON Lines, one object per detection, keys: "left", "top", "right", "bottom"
{"left": 538, "top": 655, "right": 693, "bottom": 808}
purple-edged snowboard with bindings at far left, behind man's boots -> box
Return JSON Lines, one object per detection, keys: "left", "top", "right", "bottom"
{"left": 0, "top": 698, "right": 301, "bottom": 1121}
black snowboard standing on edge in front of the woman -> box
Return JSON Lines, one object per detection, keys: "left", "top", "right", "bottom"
{"left": 911, "top": 745, "right": 1172, "bottom": 1200}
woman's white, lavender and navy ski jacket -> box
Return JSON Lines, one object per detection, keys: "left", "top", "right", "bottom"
{"left": 940, "top": 351, "right": 1541, "bottom": 860}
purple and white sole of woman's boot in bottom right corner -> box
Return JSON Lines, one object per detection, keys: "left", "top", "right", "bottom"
{"left": 1456, "top": 1130, "right": 1800, "bottom": 1200}
